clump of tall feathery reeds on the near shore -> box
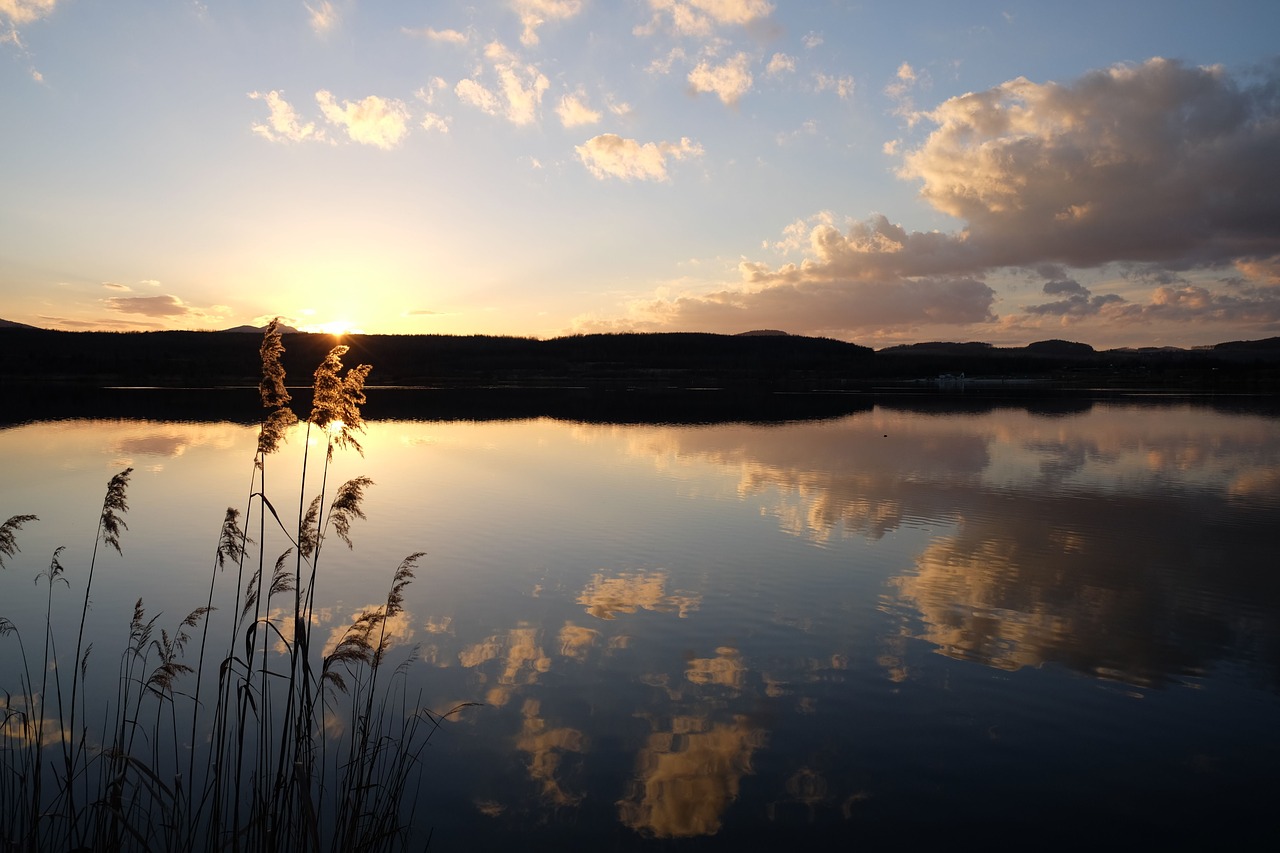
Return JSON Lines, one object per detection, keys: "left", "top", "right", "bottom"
{"left": 0, "top": 320, "right": 466, "bottom": 853}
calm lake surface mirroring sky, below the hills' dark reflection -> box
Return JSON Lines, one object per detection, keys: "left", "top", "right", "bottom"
{"left": 0, "top": 391, "right": 1280, "bottom": 849}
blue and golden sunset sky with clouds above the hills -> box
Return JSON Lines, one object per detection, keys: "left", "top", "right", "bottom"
{"left": 0, "top": 0, "right": 1280, "bottom": 348}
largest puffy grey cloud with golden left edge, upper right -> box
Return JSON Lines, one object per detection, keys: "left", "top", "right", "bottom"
{"left": 900, "top": 59, "right": 1280, "bottom": 268}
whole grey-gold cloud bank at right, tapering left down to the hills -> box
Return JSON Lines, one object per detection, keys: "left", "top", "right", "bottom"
{"left": 596, "top": 59, "right": 1280, "bottom": 338}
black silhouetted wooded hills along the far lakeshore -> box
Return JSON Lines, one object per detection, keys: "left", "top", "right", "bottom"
{"left": 0, "top": 328, "right": 1280, "bottom": 391}
